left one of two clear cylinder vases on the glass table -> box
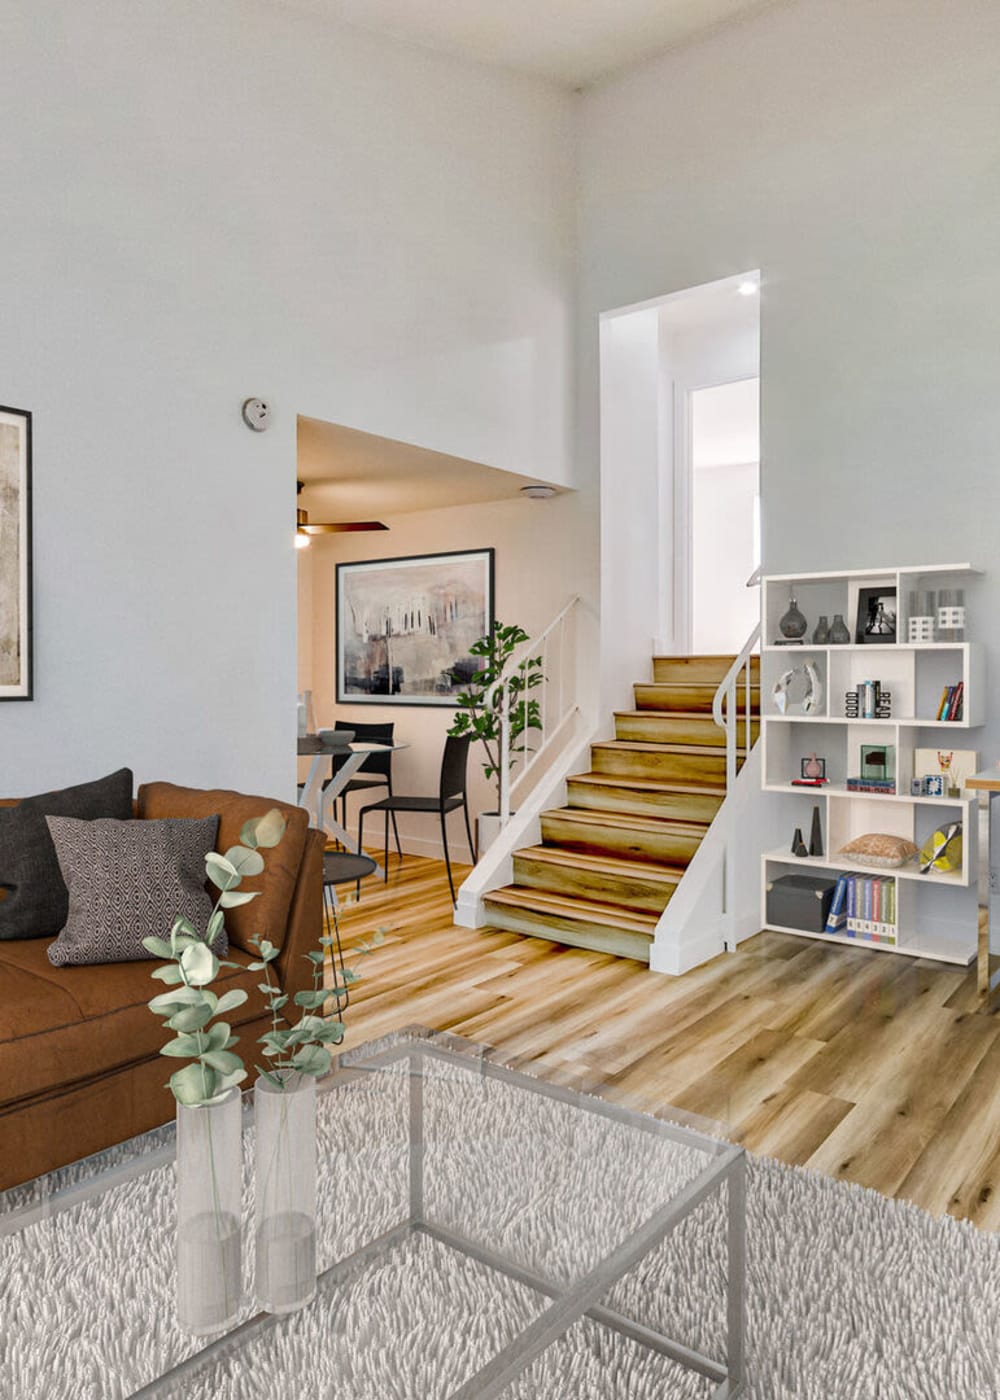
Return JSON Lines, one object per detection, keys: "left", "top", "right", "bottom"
{"left": 176, "top": 1088, "right": 242, "bottom": 1337}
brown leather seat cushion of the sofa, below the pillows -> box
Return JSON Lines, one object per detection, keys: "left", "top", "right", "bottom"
{"left": 0, "top": 938, "right": 263, "bottom": 1107}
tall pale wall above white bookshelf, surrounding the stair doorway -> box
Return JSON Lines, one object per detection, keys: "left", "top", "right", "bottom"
{"left": 580, "top": 0, "right": 1000, "bottom": 757}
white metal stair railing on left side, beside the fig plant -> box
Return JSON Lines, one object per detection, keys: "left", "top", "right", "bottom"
{"left": 485, "top": 595, "right": 580, "bottom": 826}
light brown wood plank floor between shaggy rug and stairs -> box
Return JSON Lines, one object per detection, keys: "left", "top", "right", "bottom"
{"left": 333, "top": 857, "right": 1000, "bottom": 1229}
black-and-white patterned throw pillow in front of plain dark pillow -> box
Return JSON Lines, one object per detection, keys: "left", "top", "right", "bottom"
{"left": 46, "top": 816, "right": 227, "bottom": 967}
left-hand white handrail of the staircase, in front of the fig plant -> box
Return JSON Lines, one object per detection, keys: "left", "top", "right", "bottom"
{"left": 483, "top": 594, "right": 580, "bottom": 826}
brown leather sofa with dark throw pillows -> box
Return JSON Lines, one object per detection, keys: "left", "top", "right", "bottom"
{"left": 0, "top": 783, "right": 325, "bottom": 1190}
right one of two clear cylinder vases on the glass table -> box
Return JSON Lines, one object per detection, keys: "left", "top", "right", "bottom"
{"left": 254, "top": 1074, "right": 317, "bottom": 1313}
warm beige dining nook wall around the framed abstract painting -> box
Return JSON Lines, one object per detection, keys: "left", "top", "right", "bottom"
{"left": 300, "top": 493, "right": 598, "bottom": 860}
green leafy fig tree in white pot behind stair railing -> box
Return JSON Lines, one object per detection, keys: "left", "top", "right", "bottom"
{"left": 448, "top": 619, "right": 545, "bottom": 855}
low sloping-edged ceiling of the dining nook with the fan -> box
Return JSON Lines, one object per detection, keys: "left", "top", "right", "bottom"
{"left": 298, "top": 417, "right": 546, "bottom": 525}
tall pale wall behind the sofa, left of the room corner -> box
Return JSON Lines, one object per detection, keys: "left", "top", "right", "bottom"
{"left": 0, "top": 0, "right": 573, "bottom": 795}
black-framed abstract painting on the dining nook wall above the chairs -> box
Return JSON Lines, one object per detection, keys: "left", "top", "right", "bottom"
{"left": 336, "top": 549, "right": 493, "bottom": 704}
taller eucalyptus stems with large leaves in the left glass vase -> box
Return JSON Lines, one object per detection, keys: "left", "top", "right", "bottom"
{"left": 143, "top": 809, "right": 284, "bottom": 1106}
